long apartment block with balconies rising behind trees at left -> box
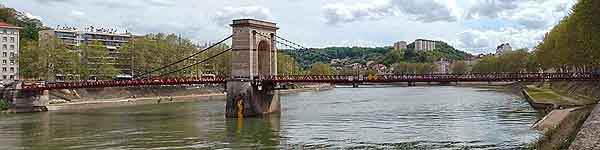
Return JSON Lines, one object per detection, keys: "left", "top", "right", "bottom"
{"left": 40, "top": 28, "right": 133, "bottom": 76}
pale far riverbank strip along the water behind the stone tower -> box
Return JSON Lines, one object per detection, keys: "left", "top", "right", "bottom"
{"left": 47, "top": 84, "right": 334, "bottom": 111}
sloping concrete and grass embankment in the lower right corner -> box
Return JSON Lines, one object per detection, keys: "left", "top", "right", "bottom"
{"left": 522, "top": 82, "right": 600, "bottom": 149}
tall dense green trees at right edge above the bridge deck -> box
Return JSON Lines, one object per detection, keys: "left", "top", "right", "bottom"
{"left": 535, "top": 0, "right": 600, "bottom": 72}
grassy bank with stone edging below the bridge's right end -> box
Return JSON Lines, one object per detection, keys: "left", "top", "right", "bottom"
{"left": 523, "top": 82, "right": 599, "bottom": 150}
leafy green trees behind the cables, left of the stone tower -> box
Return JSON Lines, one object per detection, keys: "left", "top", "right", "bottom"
{"left": 119, "top": 33, "right": 199, "bottom": 76}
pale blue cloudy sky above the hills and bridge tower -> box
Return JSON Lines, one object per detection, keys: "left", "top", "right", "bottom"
{"left": 0, "top": 0, "right": 575, "bottom": 53}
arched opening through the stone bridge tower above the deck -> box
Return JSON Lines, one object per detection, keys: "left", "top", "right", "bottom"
{"left": 257, "top": 40, "right": 271, "bottom": 76}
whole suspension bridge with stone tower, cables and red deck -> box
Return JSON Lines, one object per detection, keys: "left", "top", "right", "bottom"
{"left": 4, "top": 19, "right": 600, "bottom": 117}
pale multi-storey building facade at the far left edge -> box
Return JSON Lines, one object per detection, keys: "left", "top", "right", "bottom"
{"left": 0, "top": 22, "right": 21, "bottom": 84}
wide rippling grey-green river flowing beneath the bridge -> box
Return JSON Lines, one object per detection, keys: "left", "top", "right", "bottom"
{"left": 0, "top": 86, "right": 540, "bottom": 150}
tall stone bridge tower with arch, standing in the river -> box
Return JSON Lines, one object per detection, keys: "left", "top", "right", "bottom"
{"left": 225, "top": 19, "right": 280, "bottom": 118}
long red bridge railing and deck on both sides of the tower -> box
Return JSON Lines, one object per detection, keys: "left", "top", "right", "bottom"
{"left": 22, "top": 73, "right": 600, "bottom": 91}
